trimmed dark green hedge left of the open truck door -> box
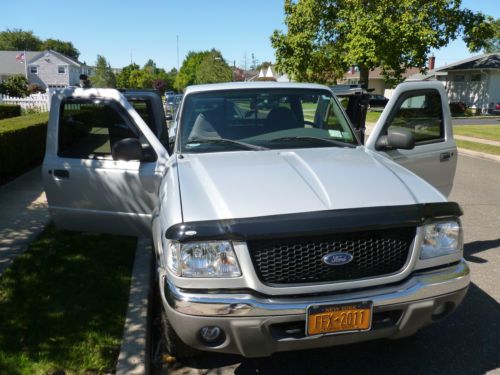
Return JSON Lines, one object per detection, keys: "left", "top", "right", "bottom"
{"left": 0, "top": 113, "right": 49, "bottom": 177}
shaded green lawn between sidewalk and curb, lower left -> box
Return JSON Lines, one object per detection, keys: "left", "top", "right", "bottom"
{"left": 0, "top": 225, "right": 136, "bottom": 375}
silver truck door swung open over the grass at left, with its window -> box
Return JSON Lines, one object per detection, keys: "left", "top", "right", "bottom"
{"left": 42, "top": 88, "right": 168, "bottom": 235}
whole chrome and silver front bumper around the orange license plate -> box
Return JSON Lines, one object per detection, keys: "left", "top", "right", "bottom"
{"left": 161, "top": 260, "right": 470, "bottom": 357}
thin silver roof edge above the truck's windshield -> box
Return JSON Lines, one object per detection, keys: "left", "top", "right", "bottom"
{"left": 185, "top": 81, "right": 330, "bottom": 95}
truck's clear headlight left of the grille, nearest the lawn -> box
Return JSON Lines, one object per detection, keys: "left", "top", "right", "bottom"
{"left": 167, "top": 241, "right": 241, "bottom": 277}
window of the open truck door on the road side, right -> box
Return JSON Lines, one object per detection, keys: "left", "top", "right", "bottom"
{"left": 387, "top": 90, "right": 444, "bottom": 145}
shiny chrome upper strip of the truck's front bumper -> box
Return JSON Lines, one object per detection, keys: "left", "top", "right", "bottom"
{"left": 161, "top": 259, "right": 470, "bottom": 317}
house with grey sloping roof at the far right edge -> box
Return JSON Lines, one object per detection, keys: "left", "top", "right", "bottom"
{"left": 410, "top": 53, "right": 500, "bottom": 113}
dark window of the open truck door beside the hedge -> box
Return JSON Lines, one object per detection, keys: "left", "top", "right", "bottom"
{"left": 58, "top": 101, "right": 139, "bottom": 159}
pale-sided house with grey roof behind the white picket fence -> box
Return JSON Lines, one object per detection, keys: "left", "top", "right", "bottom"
{"left": 0, "top": 50, "right": 91, "bottom": 89}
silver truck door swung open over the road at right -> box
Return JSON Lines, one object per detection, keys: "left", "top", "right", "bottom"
{"left": 366, "top": 82, "right": 457, "bottom": 196}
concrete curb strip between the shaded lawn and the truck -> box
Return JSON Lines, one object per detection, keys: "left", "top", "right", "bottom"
{"left": 116, "top": 238, "right": 153, "bottom": 375}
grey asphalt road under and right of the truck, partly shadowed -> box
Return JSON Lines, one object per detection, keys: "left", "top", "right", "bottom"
{"left": 163, "top": 156, "right": 500, "bottom": 375}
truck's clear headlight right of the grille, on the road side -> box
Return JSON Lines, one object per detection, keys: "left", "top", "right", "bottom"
{"left": 420, "top": 221, "right": 462, "bottom": 259}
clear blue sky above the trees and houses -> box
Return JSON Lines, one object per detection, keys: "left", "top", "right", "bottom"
{"left": 0, "top": 0, "right": 500, "bottom": 70}
